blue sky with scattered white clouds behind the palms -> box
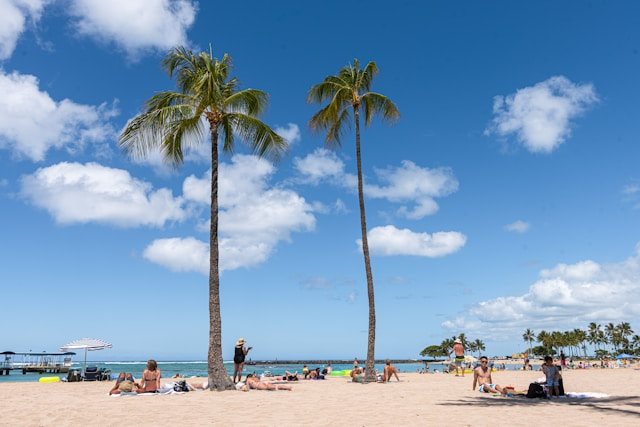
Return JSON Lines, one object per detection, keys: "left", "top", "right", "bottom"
{"left": 0, "top": 0, "right": 640, "bottom": 360}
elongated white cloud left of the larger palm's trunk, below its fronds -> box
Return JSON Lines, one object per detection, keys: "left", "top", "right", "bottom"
{"left": 21, "top": 162, "right": 186, "bottom": 227}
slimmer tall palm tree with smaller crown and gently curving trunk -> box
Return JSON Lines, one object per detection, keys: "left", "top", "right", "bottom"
{"left": 307, "top": 59, "right": 400, "bottom": 382}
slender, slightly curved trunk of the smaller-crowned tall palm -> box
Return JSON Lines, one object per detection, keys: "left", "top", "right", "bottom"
{"left": 353, "top": 106, "right": 376, "bottom": 382}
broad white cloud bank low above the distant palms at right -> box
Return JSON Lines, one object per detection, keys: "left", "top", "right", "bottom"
{"left": 443, "top": 244, "right": 640, "bottom": 339}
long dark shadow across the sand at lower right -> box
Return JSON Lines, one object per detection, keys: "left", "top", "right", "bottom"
{"left": 438, "top": 396, "right": 640, "bottom": 416}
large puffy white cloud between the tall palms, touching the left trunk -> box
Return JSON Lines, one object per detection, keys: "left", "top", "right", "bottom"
{"left": 162, "top": 155, "right": 315, "bottom": 271}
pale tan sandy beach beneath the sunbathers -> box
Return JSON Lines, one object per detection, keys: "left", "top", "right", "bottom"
{"left": 0, "top": 368, "right": 640, "bottom": 427}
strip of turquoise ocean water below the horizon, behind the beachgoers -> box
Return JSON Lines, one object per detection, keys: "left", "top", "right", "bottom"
{"left": 0, "top": 361, "right": 536, "bottom": 384}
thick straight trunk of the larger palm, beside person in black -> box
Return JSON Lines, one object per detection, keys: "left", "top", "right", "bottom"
{"left": 207, "top": 125, "right": 234, "bottom": 391}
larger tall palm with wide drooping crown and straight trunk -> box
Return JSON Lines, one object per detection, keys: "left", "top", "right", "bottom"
{"left": 119, "top": 47, "right": 287, "bottom": 391}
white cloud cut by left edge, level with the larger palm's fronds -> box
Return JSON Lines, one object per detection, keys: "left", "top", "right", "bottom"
{"left": 0, "top": 72, "right": 117, "bottom": 161}
